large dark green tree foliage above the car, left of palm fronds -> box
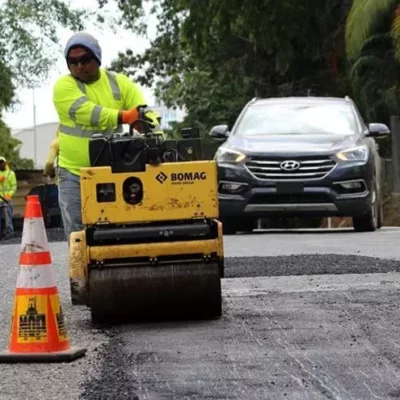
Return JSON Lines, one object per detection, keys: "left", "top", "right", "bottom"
{"left": 103, "top": 0, "right": 350, "bottom": 141}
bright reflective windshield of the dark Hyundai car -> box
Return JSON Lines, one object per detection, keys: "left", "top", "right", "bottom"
{"left": 235, "top": 104, "right": 357, "bottom": 136}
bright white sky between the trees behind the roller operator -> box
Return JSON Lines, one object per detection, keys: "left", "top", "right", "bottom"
{"left": 3, "top": 0, "right": 155, "bottom": 130}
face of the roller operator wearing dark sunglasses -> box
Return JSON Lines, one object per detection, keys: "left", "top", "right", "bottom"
{"left": 67, "top": 47, "right": 99, "bottom": 83}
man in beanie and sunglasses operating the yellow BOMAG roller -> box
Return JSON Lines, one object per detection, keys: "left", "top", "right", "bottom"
{"left": 53, "top": 32, "right": 163, "bottom": 243}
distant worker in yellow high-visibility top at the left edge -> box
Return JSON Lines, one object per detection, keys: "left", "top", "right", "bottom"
{"left": 0, "top": 157, "right": 17, "bottom": 238}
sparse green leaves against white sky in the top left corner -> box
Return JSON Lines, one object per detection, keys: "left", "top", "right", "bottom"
{"left": 0, "top": 0, "right": 86, "bottom": 91}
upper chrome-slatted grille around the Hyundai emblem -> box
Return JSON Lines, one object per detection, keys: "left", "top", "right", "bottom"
{"left": 246, "top": 156, "right": 336, "bottom": 181}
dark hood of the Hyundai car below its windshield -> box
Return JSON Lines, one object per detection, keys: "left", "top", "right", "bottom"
{"left": 224, "top": 134, "right": 360, "bottom": 155}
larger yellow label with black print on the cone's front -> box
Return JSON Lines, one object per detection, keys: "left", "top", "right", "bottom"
{"left": 14, "top": 295, "right": 48, "bottom": 343}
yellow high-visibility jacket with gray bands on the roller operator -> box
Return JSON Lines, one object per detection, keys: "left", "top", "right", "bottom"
{"left": 53, "top": 68, "right": 162, "bottom": 175}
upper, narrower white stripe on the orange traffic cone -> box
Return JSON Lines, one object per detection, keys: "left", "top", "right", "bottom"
{"left": 21, "top": 218, "right": 49, "bottom": 253}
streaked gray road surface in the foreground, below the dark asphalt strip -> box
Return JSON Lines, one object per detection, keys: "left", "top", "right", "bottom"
{"left": 104, "top": 273, "right": 400, "bottom": 400}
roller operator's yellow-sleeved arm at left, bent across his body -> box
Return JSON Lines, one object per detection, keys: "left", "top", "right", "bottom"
{"left": 53, "top": 78, "right": 119, "bottom": 128}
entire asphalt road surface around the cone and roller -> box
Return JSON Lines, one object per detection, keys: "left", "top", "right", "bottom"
{"left": 0, "top": 228, "right": 400, "bottom": 400}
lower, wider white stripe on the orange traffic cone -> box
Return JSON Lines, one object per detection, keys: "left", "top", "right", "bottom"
{"left": 17, "top": 264, "right": 56, "bottom": 289}
